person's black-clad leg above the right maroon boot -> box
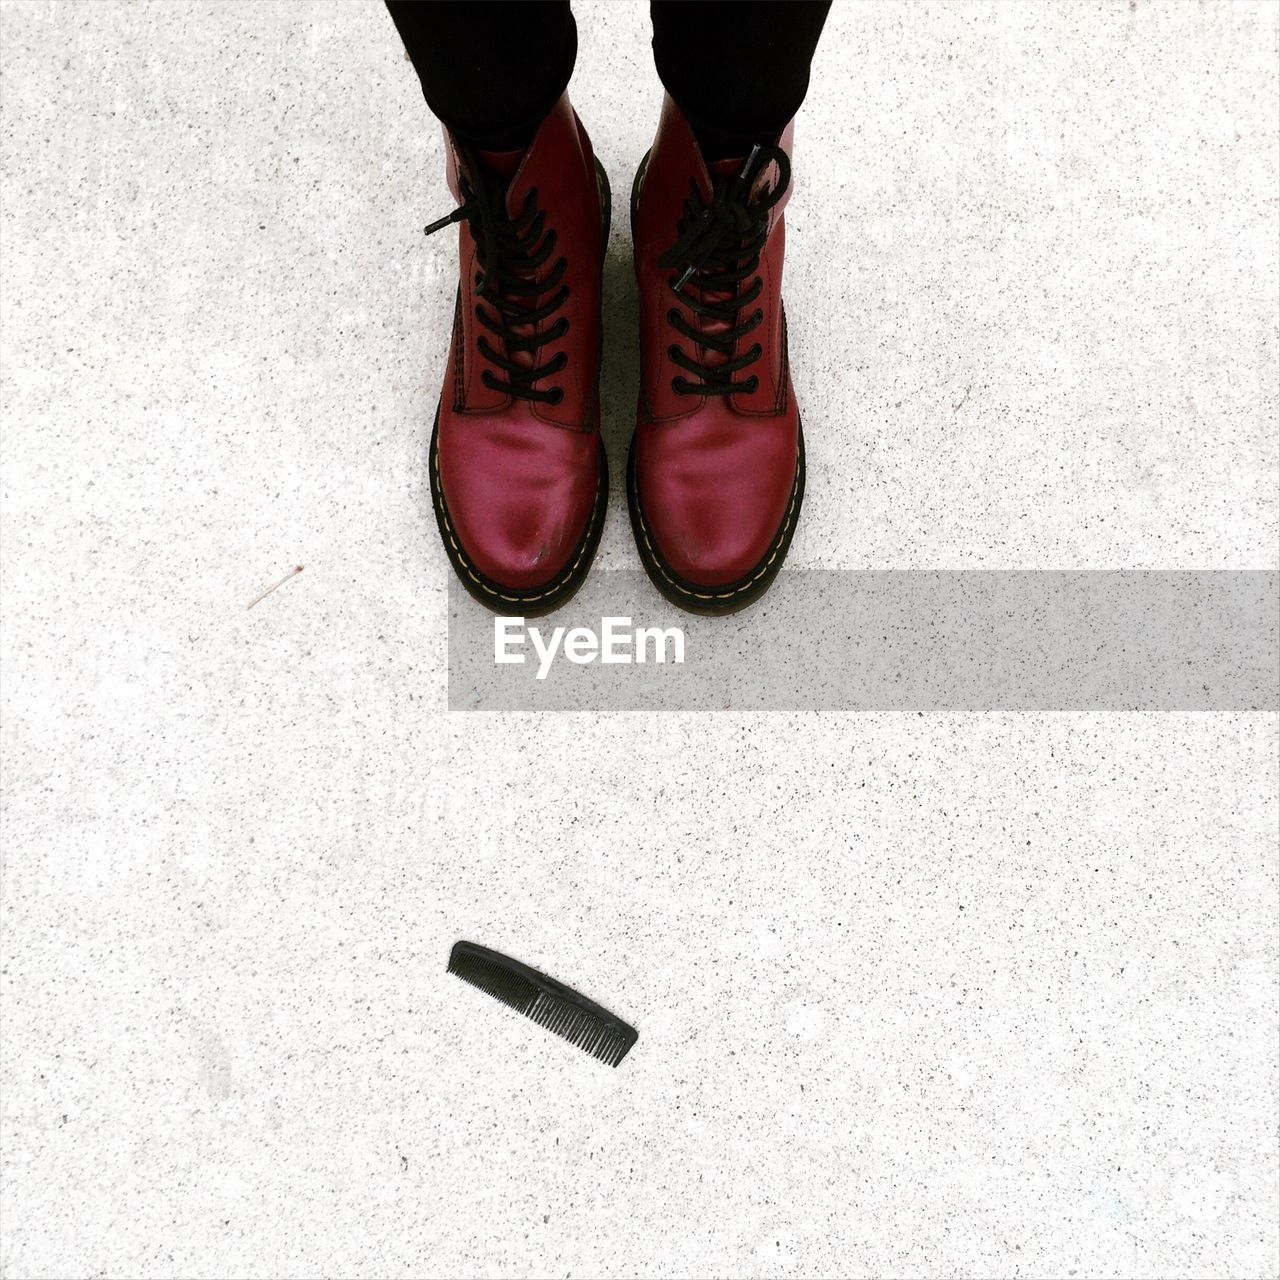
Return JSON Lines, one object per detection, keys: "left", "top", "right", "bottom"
{"left": 650, "top": 0, "right": 831, "bottom": 160}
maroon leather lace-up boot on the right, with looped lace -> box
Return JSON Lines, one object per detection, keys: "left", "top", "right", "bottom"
{"left": 627, "top": 97, "right": 804, "bottom": 613}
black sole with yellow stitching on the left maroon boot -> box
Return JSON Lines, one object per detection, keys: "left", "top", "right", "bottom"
{"left": 428, "top": 160, "right": 613, "bottom": 618}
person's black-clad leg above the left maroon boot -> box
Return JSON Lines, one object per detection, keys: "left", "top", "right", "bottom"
{"left": 387, "top": 0, "right": 577, "bottom": 151}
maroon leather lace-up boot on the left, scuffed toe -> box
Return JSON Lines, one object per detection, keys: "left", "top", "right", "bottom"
{"left": 426, "top": 95, "right": 609, "bottom": 616}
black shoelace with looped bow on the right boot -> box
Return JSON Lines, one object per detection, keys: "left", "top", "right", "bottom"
{"left": 658, "top": 146, "right": 791, "bottom": 396}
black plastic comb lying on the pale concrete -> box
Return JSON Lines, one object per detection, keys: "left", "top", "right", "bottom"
{"left": 449, "top": 942, "right": 636, "bottom": 1066}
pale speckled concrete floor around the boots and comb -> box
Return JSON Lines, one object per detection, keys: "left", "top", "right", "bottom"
{"left": 0, "top": 0, "right": 1277, "bottom": 1276}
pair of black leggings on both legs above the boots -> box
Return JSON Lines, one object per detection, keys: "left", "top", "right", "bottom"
{"left": 387, "top": 0, "right": 831, "bottom": 159}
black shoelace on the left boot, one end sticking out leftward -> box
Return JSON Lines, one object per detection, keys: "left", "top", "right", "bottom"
{"left": 424, "top": 147, "right": 568, "bottom": 404}
